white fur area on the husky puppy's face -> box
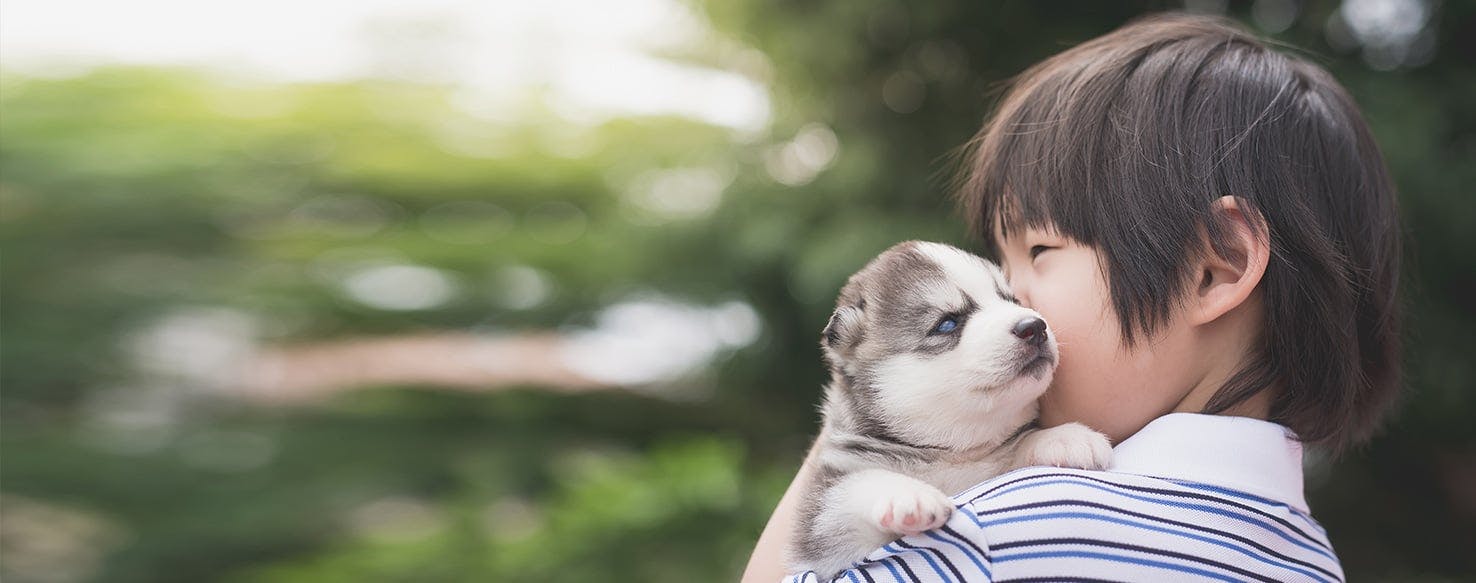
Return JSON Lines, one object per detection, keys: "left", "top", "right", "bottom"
{"left": 874, "top": 242, "right": 1057, "bottom": 449}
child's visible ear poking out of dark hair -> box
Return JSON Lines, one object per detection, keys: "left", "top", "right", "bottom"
{"left": 1188, "top": 196, "right": 1271, "bottom": 325}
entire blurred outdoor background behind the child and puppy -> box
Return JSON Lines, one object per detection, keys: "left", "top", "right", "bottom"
{"left": 0, "top": 0, "right": 1476, "bottom": 583}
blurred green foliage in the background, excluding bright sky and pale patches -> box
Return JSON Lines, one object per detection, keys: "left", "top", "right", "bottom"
{"left": 0, "top": 0, "right": 1476, "bottom": 582}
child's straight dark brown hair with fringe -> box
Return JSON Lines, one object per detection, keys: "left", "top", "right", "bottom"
{"left": 956, "top": 13, "right": 1401, "bottom": 452}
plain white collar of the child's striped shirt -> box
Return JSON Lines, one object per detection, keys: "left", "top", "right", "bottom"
{"left": 1107, "top": 413, "right": 1309, "bottom": 512}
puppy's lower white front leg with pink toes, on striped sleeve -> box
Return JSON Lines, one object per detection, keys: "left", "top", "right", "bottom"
{"left": 801, "top": 469, "right": 955, "bottom": 580}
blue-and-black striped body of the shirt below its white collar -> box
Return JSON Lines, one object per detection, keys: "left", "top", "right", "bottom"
{"left": 796, "top": 466, "right": 1343, "bottom": 582}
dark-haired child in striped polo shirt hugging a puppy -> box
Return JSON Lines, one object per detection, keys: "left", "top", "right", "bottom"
{"left": 744, "top": 15, "right": 1399, "bottom": 582}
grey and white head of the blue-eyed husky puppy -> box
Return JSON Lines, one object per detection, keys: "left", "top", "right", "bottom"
{"left": 821, "top": 241, "right": 1057, "bottom": 449}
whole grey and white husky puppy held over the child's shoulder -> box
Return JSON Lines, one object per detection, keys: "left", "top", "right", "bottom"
{"left": 788, "top": 241, "right": 1111, "bottom": 580}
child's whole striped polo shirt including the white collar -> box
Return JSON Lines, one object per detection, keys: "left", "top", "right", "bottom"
{"left": 785, "top": 413, "right": 1343, "bottom": 583}
